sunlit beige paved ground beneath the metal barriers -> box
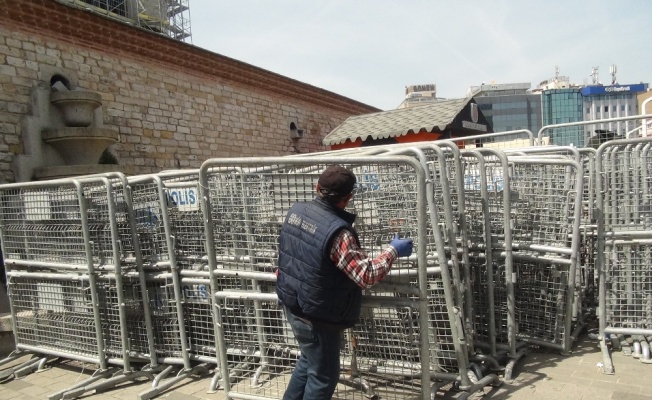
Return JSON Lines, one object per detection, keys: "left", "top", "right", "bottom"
{"left": 0, "top": 328, "right": 652, "bottom": 400}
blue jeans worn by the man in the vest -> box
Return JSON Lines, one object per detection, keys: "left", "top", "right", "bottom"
{"left": 283, "top": 308, "right": 342, "bottom": 400}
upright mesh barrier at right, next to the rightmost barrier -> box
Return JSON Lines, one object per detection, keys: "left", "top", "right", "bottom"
{"left": 506, "top": 156, "right": 583, "bottom": 353}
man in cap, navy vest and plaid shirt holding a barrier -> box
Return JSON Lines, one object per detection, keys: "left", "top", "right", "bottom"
{"left": 276, "top": 165, "right": 412, "bottom": 400}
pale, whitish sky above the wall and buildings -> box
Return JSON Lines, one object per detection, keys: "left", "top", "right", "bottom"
{"left": 189, "top": 0, "right": 652, "bottom": 110}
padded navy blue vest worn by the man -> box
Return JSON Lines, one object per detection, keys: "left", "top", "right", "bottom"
{"left": 276, "top": 198, "right": 362, "bottom": 327}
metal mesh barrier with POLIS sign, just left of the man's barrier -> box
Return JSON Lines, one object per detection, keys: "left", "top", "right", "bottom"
{"left": 128, "top": 171, "right": 216, "bottom": 399}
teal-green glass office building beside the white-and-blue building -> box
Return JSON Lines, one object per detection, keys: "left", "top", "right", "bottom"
{"left": 541, "top": 88, "right": 586, "bottom": 147}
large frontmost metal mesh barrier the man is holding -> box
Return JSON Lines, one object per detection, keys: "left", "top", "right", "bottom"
{"left": 200, "top": 155, "right": 496, "bottom": 398}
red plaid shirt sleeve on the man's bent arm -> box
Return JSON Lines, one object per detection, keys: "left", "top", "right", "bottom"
{"left": 331, "top": 229, "right": 398, "bottom": 289}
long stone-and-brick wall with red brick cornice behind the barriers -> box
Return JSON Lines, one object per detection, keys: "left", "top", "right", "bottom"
{"left": 0, "top": 0, "right": 378, "bottom": 182}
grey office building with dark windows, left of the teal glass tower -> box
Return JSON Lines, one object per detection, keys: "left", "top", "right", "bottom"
{"left": 469, "top": 83, "right": 541, "bottom": 136}
